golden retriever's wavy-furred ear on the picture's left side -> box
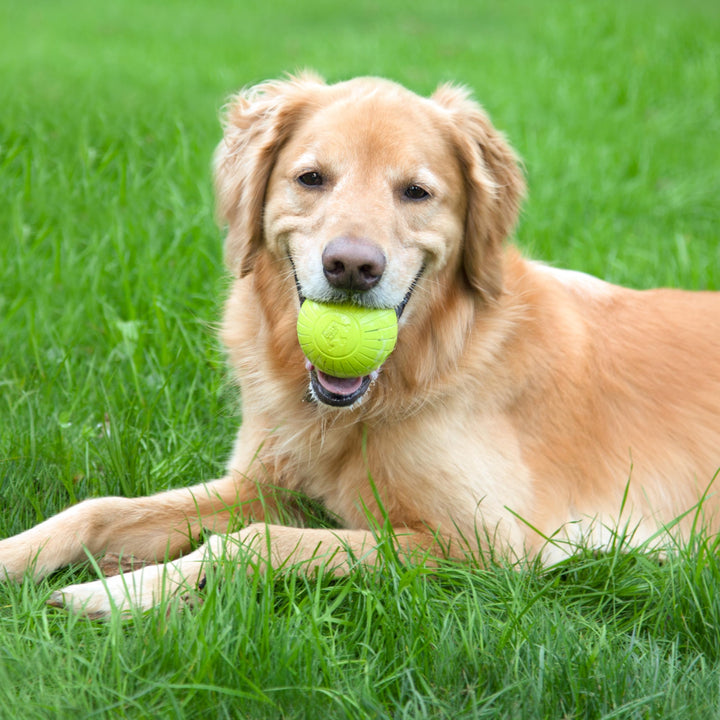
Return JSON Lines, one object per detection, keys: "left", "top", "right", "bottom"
{"left": 213, "top": 72, "right": 324, "bottom": 277}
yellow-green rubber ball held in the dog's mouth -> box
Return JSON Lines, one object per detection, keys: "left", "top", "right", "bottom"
{"left": 297, "top": 300, "right": 397, "bottom": 378}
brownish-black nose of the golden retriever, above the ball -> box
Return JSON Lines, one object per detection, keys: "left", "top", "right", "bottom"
{"left": 322, "top": 237, "right": 385, "bottom": 291}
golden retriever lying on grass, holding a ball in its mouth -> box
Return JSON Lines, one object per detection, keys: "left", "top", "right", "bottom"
{"left": 0, "top": 73, "right": 720, "bottom": 616}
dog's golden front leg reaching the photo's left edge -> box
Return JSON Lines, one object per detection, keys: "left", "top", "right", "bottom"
{"left": 0, "top": 476, "right": 264, "bottom": 581}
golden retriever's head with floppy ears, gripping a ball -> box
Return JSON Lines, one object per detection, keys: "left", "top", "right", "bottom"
{"left": 215, "top": 74, "right": 524, "bottom": 405}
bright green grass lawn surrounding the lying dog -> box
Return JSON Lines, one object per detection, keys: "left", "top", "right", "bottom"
{"left": 0, "top": 0, "right": 720, "bottom": 719}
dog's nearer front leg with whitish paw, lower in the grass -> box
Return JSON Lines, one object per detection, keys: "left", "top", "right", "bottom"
{"left": 50, "top": 523, "right": 435, "bottom": 617}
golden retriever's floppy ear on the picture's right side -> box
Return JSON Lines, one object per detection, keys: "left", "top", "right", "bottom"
{"left": 431, "top": 85, "right": 525, "bottom": 301}
